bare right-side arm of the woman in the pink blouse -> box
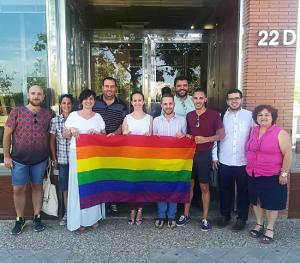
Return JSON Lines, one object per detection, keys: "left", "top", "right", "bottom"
{"left": 278, "top": 130, "right": 292, "bottom": 184}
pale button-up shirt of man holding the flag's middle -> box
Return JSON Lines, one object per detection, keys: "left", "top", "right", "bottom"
{"left": 153, "top": 113, "right": 186, "bottom": 136}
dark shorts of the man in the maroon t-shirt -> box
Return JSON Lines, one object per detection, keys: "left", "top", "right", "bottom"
{"left": 192, "top": 150, "right": 212, "bottom": 184}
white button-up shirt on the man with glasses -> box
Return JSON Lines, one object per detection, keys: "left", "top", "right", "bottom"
{"left": 219, "top": 109, "right": 255, "bottom": 166}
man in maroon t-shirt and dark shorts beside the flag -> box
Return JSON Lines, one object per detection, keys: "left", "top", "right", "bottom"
{"left": 177, "top": 89, "right": 225, "bottom": 231}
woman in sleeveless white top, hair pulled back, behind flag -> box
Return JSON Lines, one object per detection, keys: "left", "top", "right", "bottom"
{"left": 122, "top": 91, "right": 153, "bottom": 225}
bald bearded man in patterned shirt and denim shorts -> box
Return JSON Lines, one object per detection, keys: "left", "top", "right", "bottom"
{"left": 3, "top": 85, "right": 52, "bottom": 235}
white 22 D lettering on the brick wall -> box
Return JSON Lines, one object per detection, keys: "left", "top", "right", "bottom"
{"left": 257, "top": 29, "right": 296, "bottom": 46}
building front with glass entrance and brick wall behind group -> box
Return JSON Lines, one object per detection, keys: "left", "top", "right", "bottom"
{"left": 0, "top": 0, "right": 300, "bottom": 218}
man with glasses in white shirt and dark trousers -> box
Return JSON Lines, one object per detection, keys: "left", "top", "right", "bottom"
{"left": 217, "top": 89, "right": 254, "bottom": 231}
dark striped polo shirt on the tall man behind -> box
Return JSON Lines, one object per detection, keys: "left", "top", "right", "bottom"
{"left": 93, "top": 95, "right": 128, "bottom": 134}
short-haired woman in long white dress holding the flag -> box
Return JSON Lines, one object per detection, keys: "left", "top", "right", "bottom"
{"left": 64, "top": 89, "right": 105, "bottom": 231}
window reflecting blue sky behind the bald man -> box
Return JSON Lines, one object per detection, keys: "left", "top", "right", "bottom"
{"left": 0, "top": 0, "right": 50, "bottom": 163}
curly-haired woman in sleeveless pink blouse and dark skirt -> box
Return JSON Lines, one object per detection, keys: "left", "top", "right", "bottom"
{"left": 246, "top": 105, "right": 292, "bottom": 243}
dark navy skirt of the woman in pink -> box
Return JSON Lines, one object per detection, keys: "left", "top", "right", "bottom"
{"left": 248, "top": 175, "right": 287, "bottom": 211}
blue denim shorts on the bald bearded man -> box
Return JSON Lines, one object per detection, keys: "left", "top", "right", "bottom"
{"left": 11, "top": 159, "right": 48, "bottom": 186}
